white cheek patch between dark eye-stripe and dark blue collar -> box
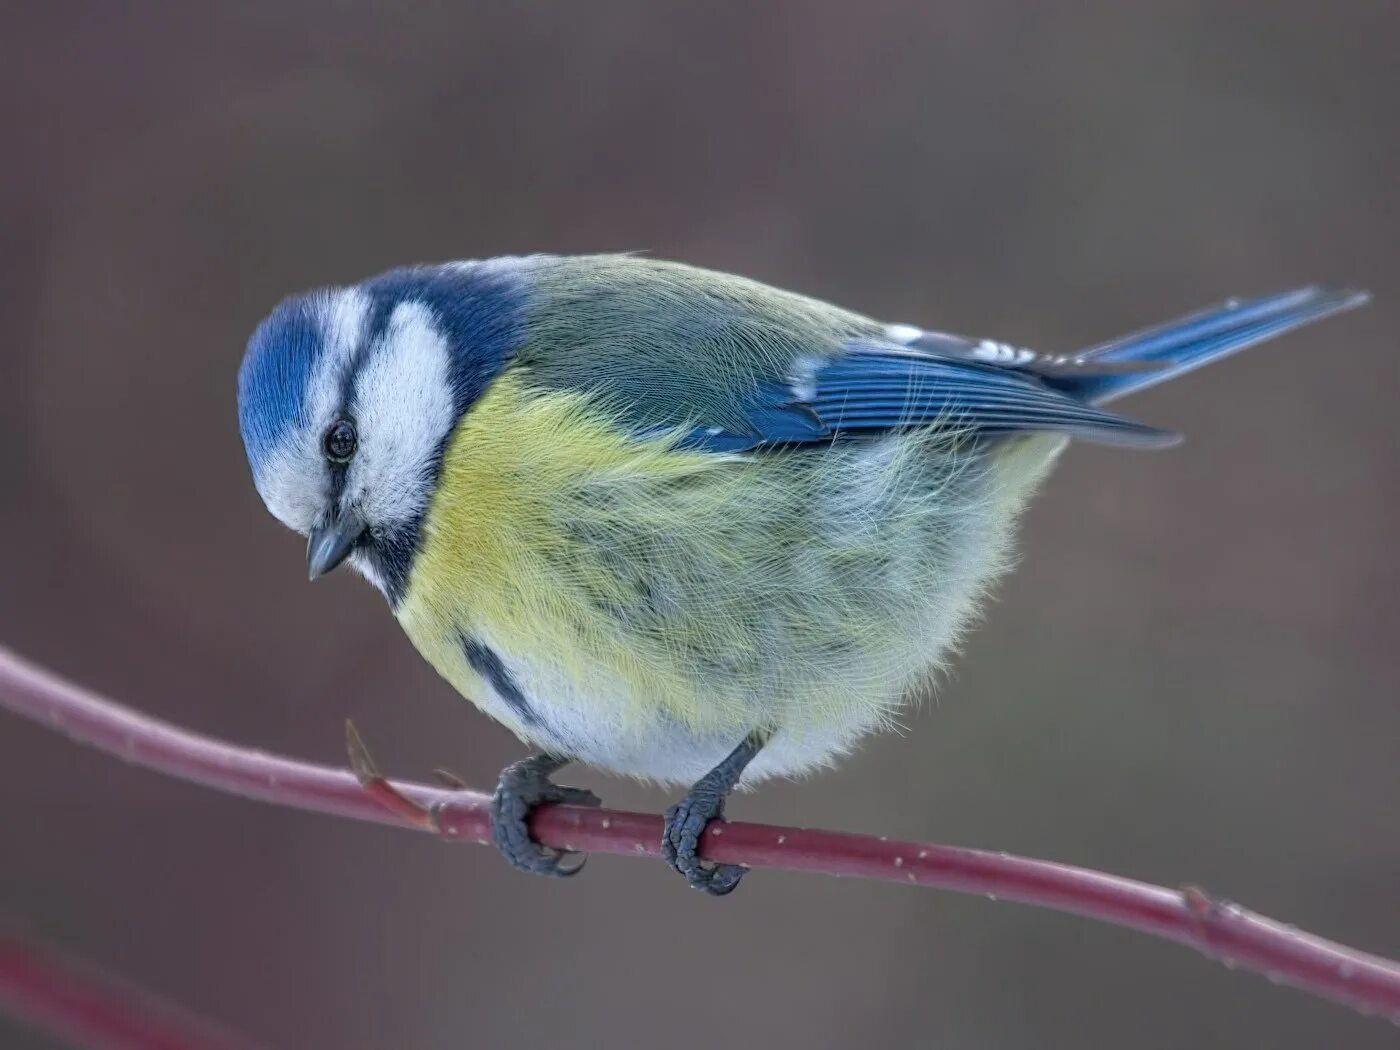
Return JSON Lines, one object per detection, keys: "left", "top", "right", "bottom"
{"left": 346, "top": 302, "right": 456, "bottom": 526}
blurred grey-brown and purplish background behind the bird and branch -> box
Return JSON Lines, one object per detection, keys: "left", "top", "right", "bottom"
{"left": 0, "top": 0, "right": 1400, "bottom": 1050}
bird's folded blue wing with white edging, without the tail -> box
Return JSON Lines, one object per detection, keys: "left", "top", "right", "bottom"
{"left": 683, "top": 342, "right": 1177, "bottom": 452}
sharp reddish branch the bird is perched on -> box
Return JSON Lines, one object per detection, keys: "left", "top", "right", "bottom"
{"left": 0, "top": 648, "right": 1400, "bottom": 1022}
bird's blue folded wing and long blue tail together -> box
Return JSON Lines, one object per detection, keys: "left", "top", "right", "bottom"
{"left": 672, "top": 287, "right": 1366, "bottom": 451}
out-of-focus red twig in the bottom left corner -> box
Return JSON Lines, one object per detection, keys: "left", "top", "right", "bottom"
{"left": 0, "top": 925, "right": 266, "bottom": 1050}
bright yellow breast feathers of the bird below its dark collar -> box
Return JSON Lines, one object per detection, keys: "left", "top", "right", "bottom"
{"left": 396, "top": 374, "right": 721, "bottom": 738}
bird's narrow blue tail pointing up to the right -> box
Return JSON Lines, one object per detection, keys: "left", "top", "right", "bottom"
{"left": 1049, "top": 286, "right": 1369, "bottom": 405}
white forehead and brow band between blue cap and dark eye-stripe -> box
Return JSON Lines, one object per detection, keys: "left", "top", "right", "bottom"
{"left": 255, "top": 288, "right": 370, "bottom": 535}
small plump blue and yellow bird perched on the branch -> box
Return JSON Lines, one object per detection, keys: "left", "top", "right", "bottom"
{"left": 238, "top": 253, "right": 1366, "bottom": 896}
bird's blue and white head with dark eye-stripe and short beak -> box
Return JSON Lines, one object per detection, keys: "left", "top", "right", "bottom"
{"left": 238, "top": 263, "right": 522, "bottom": 603}
